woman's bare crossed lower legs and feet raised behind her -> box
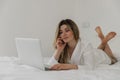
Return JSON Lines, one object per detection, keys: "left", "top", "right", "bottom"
{"left": 95, "top": 26, "right": 117, "bottom": 64}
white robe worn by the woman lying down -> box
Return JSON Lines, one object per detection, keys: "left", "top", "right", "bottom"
{"left": 48, "top": 40, "right": 111, "bottom": 69}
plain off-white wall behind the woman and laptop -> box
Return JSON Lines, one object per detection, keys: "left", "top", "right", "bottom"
{"left": 0, "top": 0, "right": 120, "bottom": 56}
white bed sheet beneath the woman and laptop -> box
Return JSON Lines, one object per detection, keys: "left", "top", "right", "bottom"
{"left": 0, "top": 57, "right": 120, "bottom": 80}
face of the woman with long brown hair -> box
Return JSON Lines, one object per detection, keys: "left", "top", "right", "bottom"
{"left": 59, "top": 25, "right": 74, "bottom": 43}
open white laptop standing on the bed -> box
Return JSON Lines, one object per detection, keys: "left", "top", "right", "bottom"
{"left": 15, "top": 38, "right": 49, "bottom": 70}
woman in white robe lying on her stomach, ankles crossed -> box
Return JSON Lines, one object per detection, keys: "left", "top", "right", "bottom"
{"left": 48, "top": 19, "right": 117, "bottom": 70}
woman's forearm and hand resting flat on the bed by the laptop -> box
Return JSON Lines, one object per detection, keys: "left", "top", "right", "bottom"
{"left": 51, "top": 64, "right": 78, "bottom": 70}
